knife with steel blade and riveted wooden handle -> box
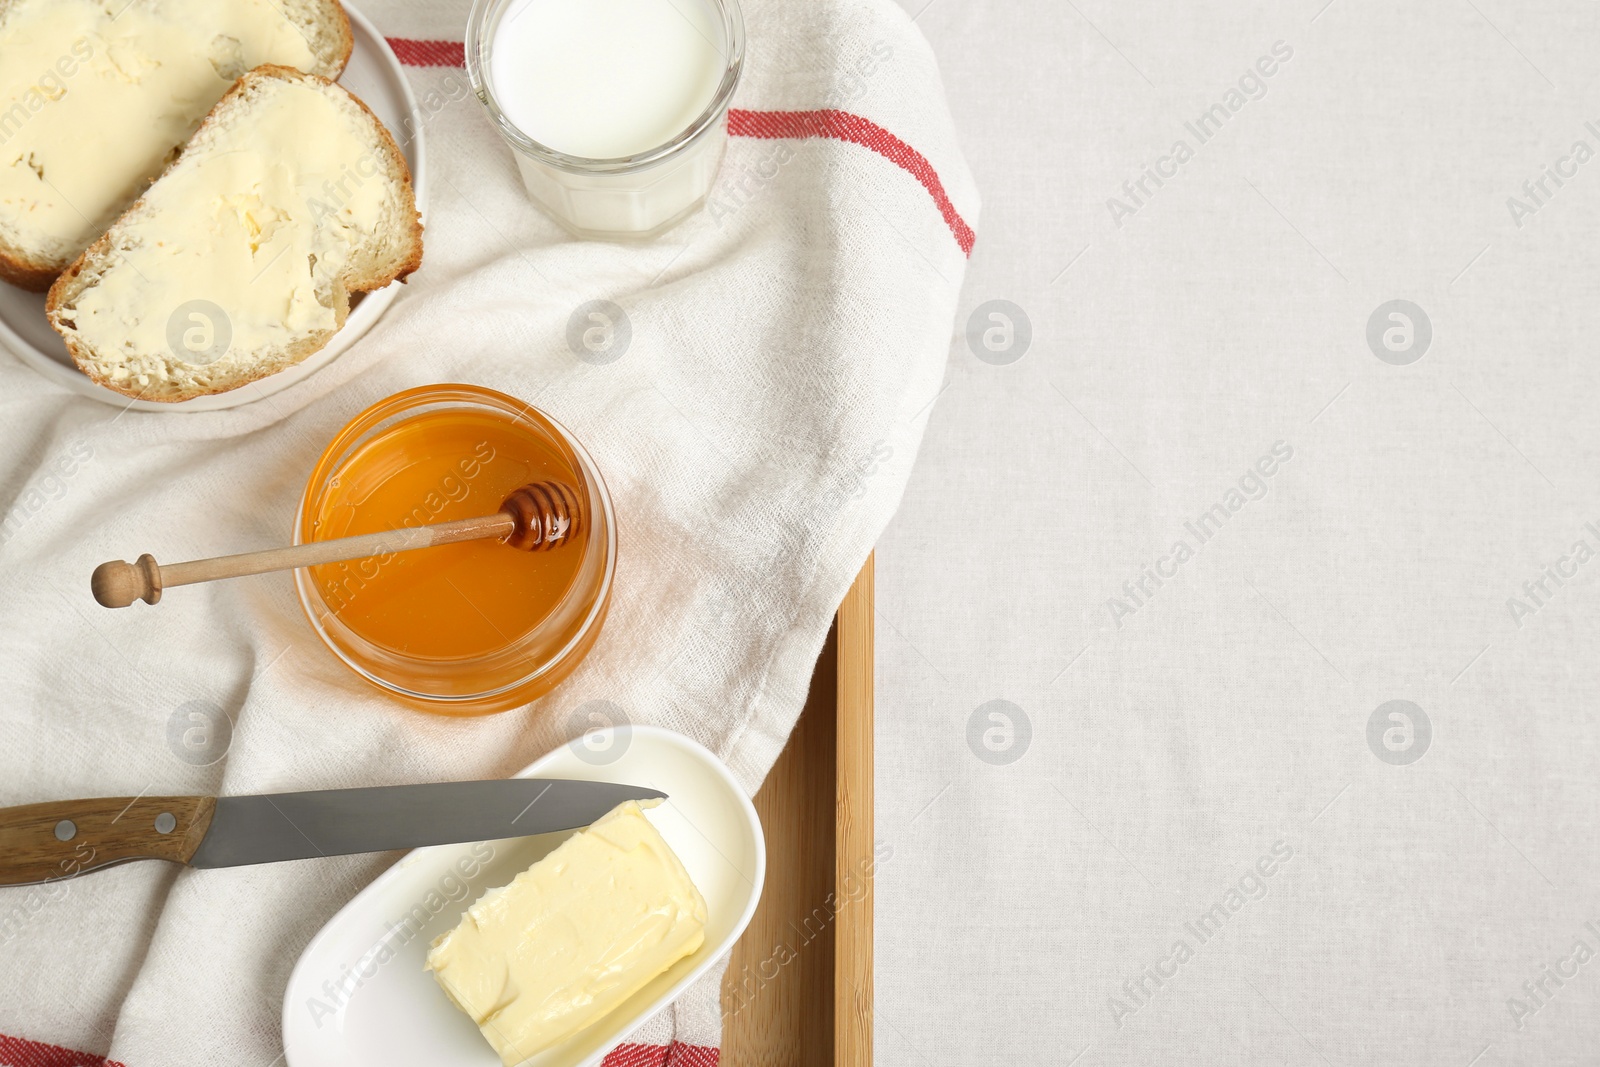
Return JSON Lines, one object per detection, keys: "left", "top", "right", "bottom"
{"left": 0, "top": 777, "right": 666, "bottom": 886}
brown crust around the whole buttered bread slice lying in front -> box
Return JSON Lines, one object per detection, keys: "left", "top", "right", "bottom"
{"left": 45, "top": 64, "right": 422, "bottom": 403}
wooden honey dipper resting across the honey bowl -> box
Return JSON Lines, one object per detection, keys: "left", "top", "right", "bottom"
{"left": 90, "top": 482, "right": 582, "bottom": 608}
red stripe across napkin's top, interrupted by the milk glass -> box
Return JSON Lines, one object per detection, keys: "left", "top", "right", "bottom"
{"left": 380, "top": 37, "right": 978, "bottom": 256}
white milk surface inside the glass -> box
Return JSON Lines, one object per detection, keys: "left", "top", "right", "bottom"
{"left": 488, "top": 0, "right": 728, "bottom": 158}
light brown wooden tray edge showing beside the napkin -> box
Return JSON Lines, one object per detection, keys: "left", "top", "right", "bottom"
{"left": 722, "top": 557, "right": 872, "bottom": 1067}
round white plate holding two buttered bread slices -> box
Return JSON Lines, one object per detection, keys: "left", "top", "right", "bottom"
{"left": 0, "top": 3, "right": 427, "bottom": 411}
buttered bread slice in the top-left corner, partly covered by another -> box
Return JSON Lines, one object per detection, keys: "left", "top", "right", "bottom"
{"left": 0, "top": 0, "right": 354, "bottom": 291}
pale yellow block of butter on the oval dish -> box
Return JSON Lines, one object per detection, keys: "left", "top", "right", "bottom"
{"left": 427, "top": 800, "right": 706, "bottom": 1067}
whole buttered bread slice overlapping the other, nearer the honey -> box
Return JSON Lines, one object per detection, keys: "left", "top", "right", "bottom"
{"left": 46, "top": 66, "right": 422, "bottom": 402}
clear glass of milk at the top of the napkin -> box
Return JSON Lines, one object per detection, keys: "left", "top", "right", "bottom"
{"left": 467, "top": 0, "right": 744, "bottom": 238}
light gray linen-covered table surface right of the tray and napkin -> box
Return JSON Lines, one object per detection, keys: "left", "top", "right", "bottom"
{"left": 875, "top": 0, "right": 1600, "bottom": 1067}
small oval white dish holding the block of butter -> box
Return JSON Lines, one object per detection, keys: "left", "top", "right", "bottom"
{"left": 283, "top": 726, "right": 766, "bottom": 1067}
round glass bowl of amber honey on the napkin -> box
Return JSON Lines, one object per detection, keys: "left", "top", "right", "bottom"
{"left": 294, "top": 386, "right": 616, "bottom": 715}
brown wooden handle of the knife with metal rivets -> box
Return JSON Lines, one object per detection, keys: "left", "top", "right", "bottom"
{"left": 0, "top": 797, "right": 216, "bottom": 886}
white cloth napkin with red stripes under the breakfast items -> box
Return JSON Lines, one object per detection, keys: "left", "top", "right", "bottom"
{"left": 0, "top": 0, "right": 978, "bottom": 1067}
